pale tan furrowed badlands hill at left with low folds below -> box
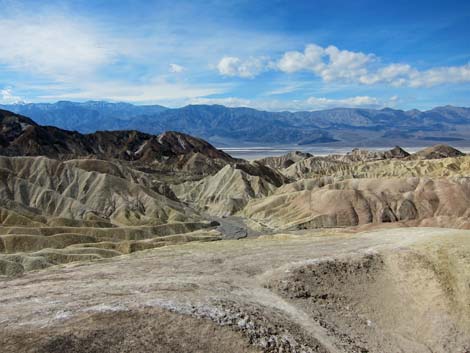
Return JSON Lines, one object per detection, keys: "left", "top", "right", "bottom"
{"left": 0, "top": 157, "right": 221, "bottom": 274}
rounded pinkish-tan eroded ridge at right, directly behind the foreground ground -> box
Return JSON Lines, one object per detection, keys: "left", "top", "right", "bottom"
{"left": 243, "top": 177, "right": 470, "bottom": 229}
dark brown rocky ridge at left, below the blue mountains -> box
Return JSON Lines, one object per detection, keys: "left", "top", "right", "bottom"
{"left": 0, "top": 110, "right": 235, "bottom": 170}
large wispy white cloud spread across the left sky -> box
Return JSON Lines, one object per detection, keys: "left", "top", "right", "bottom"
{"left": 0, "top": 9, "right": 234, "bottom": 103}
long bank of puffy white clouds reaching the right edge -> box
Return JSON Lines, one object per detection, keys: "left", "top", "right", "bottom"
{"left": 218, "top": 44, "right": 470, "bottom": 87}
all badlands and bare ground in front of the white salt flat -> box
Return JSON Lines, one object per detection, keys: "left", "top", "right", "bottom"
{"left": 0, "top": 111, "right": 470, "bottom": 353}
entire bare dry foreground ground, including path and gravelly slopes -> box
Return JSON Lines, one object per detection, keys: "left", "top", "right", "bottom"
{"left": 0, "top": 228, "right": 470, "bottom": 353}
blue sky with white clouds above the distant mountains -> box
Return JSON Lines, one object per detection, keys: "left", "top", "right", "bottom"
{"left": 0, "top": 0, "right": 470, "bottom": 111}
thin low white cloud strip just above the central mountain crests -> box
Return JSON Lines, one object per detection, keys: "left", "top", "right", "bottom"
{"left": 188, "top": 96, "right": 398, "bottom": 111}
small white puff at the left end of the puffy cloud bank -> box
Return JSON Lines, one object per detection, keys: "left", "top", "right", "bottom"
{"left": 217, "top": 56, "right": 269, "bottom": 78}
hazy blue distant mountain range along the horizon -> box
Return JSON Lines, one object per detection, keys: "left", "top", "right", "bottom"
{"left": 0, "top": 101, "right": 470, "bottom": 146}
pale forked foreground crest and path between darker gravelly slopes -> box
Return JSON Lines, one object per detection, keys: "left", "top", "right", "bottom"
{"left": 0, "top": 228, "right": 470, "bottom": 352}
